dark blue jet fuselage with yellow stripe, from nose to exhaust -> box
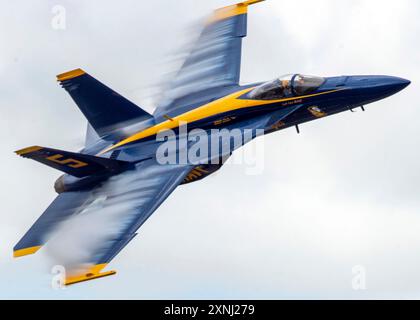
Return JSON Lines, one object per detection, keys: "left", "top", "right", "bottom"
{"left": 60, "top": 75, "right": 410, "bottom": 188}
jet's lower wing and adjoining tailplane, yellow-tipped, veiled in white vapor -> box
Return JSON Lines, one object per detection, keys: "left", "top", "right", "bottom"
{"left": 15, "top": 159, "right": 192, "bottom": 285}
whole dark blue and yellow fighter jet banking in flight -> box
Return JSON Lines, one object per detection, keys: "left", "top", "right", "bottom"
{"left": 14, "top": 0, "right": 410, "bottom": 284}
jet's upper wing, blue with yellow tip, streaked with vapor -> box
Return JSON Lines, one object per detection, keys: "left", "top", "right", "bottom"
{"left": 154, "top": 0, "right": 264, "bottom": 118}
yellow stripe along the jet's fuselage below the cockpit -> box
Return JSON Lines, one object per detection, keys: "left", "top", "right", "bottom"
{"left": 98, "top": 87, "right": 342, "bottom": 155}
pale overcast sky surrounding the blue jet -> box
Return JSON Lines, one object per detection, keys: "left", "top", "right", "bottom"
{"left": 0, "top": 0, "right": 420, "bottom": 299}
